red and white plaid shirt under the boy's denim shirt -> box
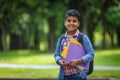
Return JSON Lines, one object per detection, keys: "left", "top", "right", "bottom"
{"left": 62, "top": 30, "right": 80, "bottom": 76}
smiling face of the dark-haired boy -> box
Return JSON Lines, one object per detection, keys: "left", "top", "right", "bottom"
{"left": 64, "top": 16, "right": 80, "bottom": 31}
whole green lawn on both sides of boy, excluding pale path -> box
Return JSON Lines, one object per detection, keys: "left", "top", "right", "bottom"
{"left": 0, "top": 49, "right": 120, "bottom": 78}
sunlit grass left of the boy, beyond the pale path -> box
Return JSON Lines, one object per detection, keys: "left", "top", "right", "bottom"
{"left": 0, "top": 50, "right": 55, "bottom": 64}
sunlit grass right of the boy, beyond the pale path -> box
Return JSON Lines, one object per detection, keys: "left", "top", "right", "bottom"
{"left": 94, "top": 50, "right": 120, "bottom": 66}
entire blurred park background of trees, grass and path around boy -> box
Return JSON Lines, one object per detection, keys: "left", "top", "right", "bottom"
{"left": 0, "top": 0, "right": 120, "bottom": 80}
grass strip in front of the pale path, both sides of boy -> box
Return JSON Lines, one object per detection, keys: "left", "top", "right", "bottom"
{"left": 0, "top": 68, "right": 120, "bottom": 79}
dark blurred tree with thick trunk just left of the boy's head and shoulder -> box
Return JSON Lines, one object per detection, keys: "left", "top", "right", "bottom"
{"left": 47, "top": 0, "right": 66, "bottom": 51}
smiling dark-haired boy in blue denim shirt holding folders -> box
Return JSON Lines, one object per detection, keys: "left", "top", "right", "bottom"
{"left": 54, "top": 9, "right": 94, "bottom": 80}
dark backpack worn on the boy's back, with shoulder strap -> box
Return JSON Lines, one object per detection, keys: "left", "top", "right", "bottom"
{"left": 78, "top": 33, "right": 94, "bottom": 75}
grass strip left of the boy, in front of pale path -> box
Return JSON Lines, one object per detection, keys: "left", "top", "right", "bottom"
{"left": 0, "top": 68, "right": 58, "bottom": 78}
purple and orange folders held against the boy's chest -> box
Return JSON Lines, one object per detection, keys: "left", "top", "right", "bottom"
{"left": 61, "top": 38, "right": 89, "bottom": 70}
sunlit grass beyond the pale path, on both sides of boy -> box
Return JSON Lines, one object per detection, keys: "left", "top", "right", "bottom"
{"left": 0, "top": 49, "right": 120, "bottom": 66}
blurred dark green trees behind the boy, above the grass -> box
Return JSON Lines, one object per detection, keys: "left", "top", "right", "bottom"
{"left": 0, "top": 0, "right": 120, "bottom": 51}
